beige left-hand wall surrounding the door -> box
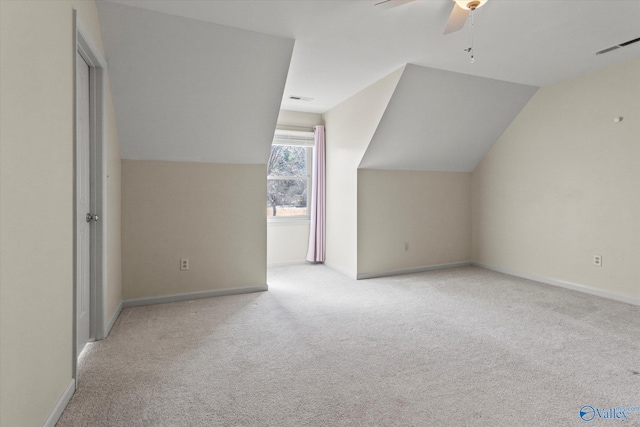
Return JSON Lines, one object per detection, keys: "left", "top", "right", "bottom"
{"left": 0, "top": 0, "right": 120, "bottom": 427}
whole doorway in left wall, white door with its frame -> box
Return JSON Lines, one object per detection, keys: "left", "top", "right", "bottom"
{"left": 72, "top": 15, "right": 106, "bottom": 387}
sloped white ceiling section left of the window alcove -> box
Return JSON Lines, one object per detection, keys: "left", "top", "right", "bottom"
{"left": 97, "top": 2, "right": 294, "bottom": 164}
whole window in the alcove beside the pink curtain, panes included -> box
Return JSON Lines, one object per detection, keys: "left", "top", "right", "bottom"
{"left": 267, "top": 130, "right": 313, "bottom": 219}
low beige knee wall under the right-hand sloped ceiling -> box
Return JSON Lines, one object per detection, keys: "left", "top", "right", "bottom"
{"left": 358, "top": 169, "right": 471, "bottom": 275}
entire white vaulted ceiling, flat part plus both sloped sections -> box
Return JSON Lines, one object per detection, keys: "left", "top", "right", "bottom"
{"left": 97, "top": 0, "right": 640, "bottom": 171}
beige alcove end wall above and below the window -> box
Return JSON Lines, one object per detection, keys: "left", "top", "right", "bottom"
{"left": 267, "top": 110, "right": 322, "bottom": 266}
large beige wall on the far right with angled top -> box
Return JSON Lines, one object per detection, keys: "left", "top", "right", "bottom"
{"left": 472, "top": 59, "right": 640, "bottom": 300}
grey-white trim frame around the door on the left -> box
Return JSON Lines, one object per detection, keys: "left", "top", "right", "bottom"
{"left": 72, "top": 9, "right": 107, "bottom": 387}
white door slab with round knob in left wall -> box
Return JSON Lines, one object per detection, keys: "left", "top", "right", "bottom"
{"left": 76, "top": 53, "right": 93, "bottom": 356}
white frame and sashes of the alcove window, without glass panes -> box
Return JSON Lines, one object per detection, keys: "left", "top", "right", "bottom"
{"left": 267, "top": 129, "right": 315, "bottom": 223}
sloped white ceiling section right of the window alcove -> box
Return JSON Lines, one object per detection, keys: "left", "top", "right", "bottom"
{"left": 359, "top": 64, "right": 538, "bottom": 172}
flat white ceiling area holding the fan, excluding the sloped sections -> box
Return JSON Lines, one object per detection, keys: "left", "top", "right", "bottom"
{"left": 98, "top": 0, "right": 640, "bottom": 113}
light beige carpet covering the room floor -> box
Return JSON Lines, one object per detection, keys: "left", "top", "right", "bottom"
{"left": 58, "top": 265, "right": 640, "bottom": 427}
